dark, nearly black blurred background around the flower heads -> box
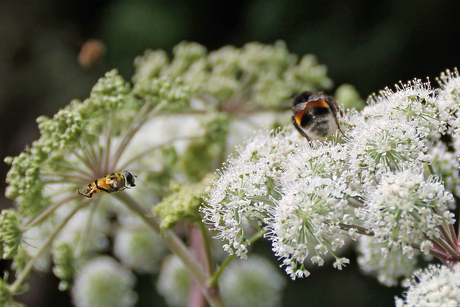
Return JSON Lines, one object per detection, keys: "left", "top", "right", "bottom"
{"left": 0, "top": 0, "right": 460, "bottom": 306}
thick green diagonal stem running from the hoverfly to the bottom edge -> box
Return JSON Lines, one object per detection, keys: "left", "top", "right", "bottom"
{"left": 115, "top": 193, "right": 225, "bottom": 307}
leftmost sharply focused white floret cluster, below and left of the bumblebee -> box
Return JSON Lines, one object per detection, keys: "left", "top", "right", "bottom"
{"left": 201, "top": 132, "right": 295, "bottom": 259}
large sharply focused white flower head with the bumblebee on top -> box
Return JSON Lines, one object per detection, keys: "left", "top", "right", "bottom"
{"left": 202, "top": 71, "right": 460, "bottom": 284}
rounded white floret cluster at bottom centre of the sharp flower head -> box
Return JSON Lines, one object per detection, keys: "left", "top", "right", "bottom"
{"left": 266, "top": 176, "right": 349, "bottom": 279}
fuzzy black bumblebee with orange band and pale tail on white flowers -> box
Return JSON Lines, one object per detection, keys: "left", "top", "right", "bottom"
{"left": 292, "top": 92, "right": 344, "bottom": 141}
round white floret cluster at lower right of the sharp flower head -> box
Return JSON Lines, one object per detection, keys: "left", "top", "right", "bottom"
{"left": 356, "top": 167, "right": 455, "bottom": 258}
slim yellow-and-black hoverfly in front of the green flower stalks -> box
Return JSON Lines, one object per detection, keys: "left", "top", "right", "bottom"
{"left": 77, "top": 171, "right": 137, "bottom": 198}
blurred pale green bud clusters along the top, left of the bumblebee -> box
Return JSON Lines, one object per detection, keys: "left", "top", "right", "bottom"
{"left": 133, "top": 41, "right": 332, "bottom": 112}
